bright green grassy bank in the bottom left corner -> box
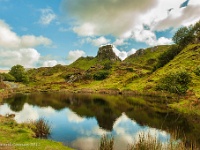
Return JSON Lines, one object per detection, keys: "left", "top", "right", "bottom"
{"left": 0, "top": 116, "right": 71, "bottom": 150}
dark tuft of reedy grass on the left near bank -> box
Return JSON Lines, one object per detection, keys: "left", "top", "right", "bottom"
{"left": 32, "top": 118, "right": 51, "bottom": 138}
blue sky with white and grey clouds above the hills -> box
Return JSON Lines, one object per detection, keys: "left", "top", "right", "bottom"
{"left": 0, "top": 0, "right": 200, "bottom": 69}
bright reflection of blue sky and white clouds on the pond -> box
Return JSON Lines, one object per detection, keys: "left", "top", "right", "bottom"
{"left": 0, "top": 103, "right": 169, "bottom": 150}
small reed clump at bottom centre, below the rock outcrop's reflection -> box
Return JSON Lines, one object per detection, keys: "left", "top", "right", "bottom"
{"left": 99, "top": 135, "right": 114, "bottom": 150}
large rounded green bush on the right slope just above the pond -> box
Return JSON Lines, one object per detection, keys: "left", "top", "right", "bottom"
{"left": 156, "top": 71, "right": 191, "bottom": 94}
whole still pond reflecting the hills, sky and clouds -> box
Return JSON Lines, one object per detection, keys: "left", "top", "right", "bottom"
{"left": 0, "top": 93, "right": 200, "bottom": 150}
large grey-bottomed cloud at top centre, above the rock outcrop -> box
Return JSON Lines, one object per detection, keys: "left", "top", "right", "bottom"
{"left": 62, "top": 0, "right": 157, "bottom": 36}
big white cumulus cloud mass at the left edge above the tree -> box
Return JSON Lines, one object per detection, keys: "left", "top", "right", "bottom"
{"left": 0, "top": 20, "right": 52, "bottom": 68}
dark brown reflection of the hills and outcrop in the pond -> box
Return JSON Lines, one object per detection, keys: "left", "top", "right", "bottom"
{"left": 0, "top": 92, "right": 200, "bottom": 149}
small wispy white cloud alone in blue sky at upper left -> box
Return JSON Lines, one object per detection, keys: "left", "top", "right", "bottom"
{"left": 39, "top": 8, "right": 56, "bottom": 25}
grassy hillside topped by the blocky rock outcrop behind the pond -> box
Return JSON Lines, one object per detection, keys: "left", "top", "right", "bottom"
{"left": 25, "top": 45, "right": 169, "bottom": 90}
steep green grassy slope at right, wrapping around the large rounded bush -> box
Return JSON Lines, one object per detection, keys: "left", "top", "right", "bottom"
{"left": 125, "top": 44, "right": 200, "bottom": 115}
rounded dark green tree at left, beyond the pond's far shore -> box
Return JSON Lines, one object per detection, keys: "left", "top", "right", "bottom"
{"left": 9, "top": 65, "right": 29, "bottom": 83}
